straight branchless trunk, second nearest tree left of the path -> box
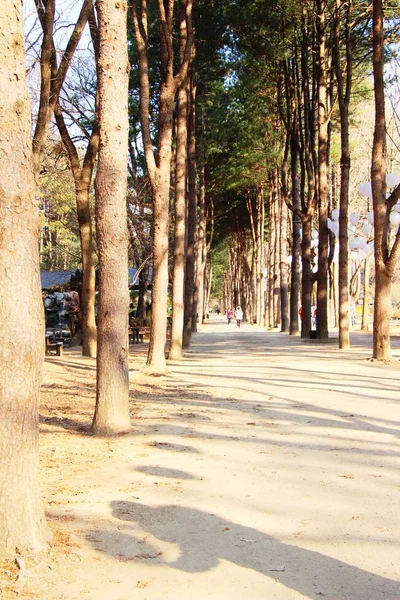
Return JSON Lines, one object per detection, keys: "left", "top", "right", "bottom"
{"left": 93, "top": 0, "right": 130, "bottom": 434}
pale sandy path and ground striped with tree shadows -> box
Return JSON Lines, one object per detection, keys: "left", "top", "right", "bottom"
{"left": 0, "top": 317, "right": 400, "bottom": 600}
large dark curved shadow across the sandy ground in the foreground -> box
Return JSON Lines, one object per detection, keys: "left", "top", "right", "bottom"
{"left": 87, "top": 501, "right": 400, "bottom": 600}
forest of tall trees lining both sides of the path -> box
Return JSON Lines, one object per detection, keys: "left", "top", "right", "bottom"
{"left": 0, "top": 0, "right": 400, "bottom": 568}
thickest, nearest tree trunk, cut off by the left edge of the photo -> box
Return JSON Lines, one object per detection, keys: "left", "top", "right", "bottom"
{"left": 0, "top": 0, "right": 49, "bottom": 555}
